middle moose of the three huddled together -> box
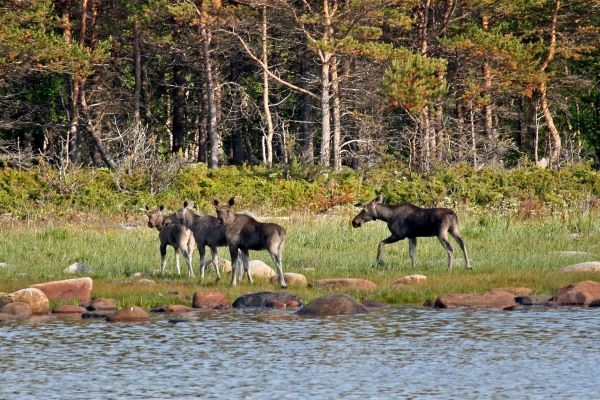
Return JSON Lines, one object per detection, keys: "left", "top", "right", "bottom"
{"left": 177, "top": 201, "right": 227, "bottom": 280}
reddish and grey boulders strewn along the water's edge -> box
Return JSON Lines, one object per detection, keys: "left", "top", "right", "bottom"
{"left": 0, "top": 272, "right": 600, "bottom": 322}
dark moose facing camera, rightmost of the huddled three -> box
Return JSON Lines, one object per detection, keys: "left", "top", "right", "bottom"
{"left": 213, "top": 197, "right": 287, "bottom": 288}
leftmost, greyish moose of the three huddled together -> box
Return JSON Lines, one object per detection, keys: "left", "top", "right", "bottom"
{"left": 146, "top": 205, "right": 195, "bottom": 278}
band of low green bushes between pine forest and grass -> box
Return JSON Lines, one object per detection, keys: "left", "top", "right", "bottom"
{"left": 0, "top": 164, "right": 600, "bottom": 219}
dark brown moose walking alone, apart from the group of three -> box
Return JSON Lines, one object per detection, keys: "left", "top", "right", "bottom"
{"left": 352, "top": 195, "right": 471, "bottom": 271}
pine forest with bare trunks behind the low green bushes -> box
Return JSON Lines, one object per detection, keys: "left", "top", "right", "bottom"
{"left": 0, "top": 0, "right": 600, "bottom": 173}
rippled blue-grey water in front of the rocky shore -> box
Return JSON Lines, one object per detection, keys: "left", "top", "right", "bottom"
{"left": 0, "top": 307, "right": 600, "bottom": 400}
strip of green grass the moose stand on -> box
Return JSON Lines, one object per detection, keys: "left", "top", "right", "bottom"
{"left": 0, "top": 208, "right": 600, "bottom": 308}
